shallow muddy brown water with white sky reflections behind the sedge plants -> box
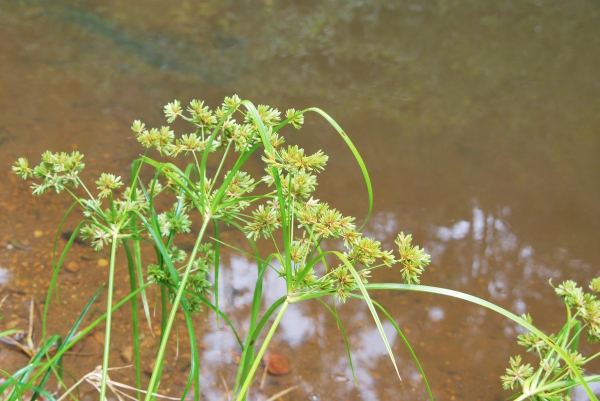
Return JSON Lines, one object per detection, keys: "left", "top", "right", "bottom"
{"left": 0, "top": 0, "right": 600, "bottom": 400}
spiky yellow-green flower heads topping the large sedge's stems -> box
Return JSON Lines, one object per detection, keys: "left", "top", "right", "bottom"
{"left": 13, "top": 95, "right": 429, "bottom": 332}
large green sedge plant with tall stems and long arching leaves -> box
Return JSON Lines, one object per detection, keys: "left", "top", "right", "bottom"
{"left": 8, "top": 96, "right": 595, "bottom": 401}
